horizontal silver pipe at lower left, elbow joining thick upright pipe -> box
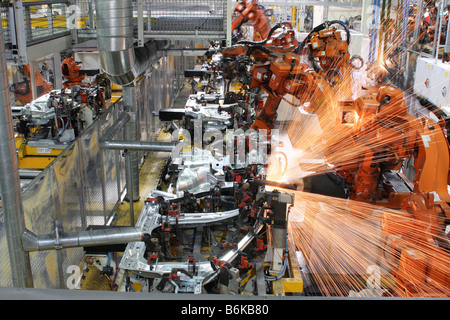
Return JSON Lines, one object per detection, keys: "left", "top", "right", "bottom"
{"left": 22, "top": 227, "right": 142, "bottom": 251}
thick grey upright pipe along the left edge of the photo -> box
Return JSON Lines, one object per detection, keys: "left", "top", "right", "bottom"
{"left": 0, "top": 23, "right": 33, "bottom": 288}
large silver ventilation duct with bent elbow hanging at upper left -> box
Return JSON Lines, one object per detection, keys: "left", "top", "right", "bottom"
{"left": 95, "top": 0, "right": 169, "bottom": 86}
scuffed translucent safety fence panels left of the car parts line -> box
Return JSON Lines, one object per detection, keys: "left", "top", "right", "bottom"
{"left": 0, "top": 53, "right": 189, "bottom": 288}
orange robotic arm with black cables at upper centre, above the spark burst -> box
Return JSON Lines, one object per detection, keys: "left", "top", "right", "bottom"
{"left": 222, "top": 21, "right": 356, "bottom": 131}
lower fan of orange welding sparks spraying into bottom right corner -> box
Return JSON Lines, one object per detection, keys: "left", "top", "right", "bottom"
{"left": 289, "top": 191, "right": 450, "bottom": 297}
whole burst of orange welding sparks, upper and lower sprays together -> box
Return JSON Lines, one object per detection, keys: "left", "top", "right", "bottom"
{"left": 267, "top": 13, "right": 450, "bottom": 297}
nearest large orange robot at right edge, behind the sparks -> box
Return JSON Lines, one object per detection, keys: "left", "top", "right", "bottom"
{"left": 327, "top": 85, "right": 450, "bottom": 297}
